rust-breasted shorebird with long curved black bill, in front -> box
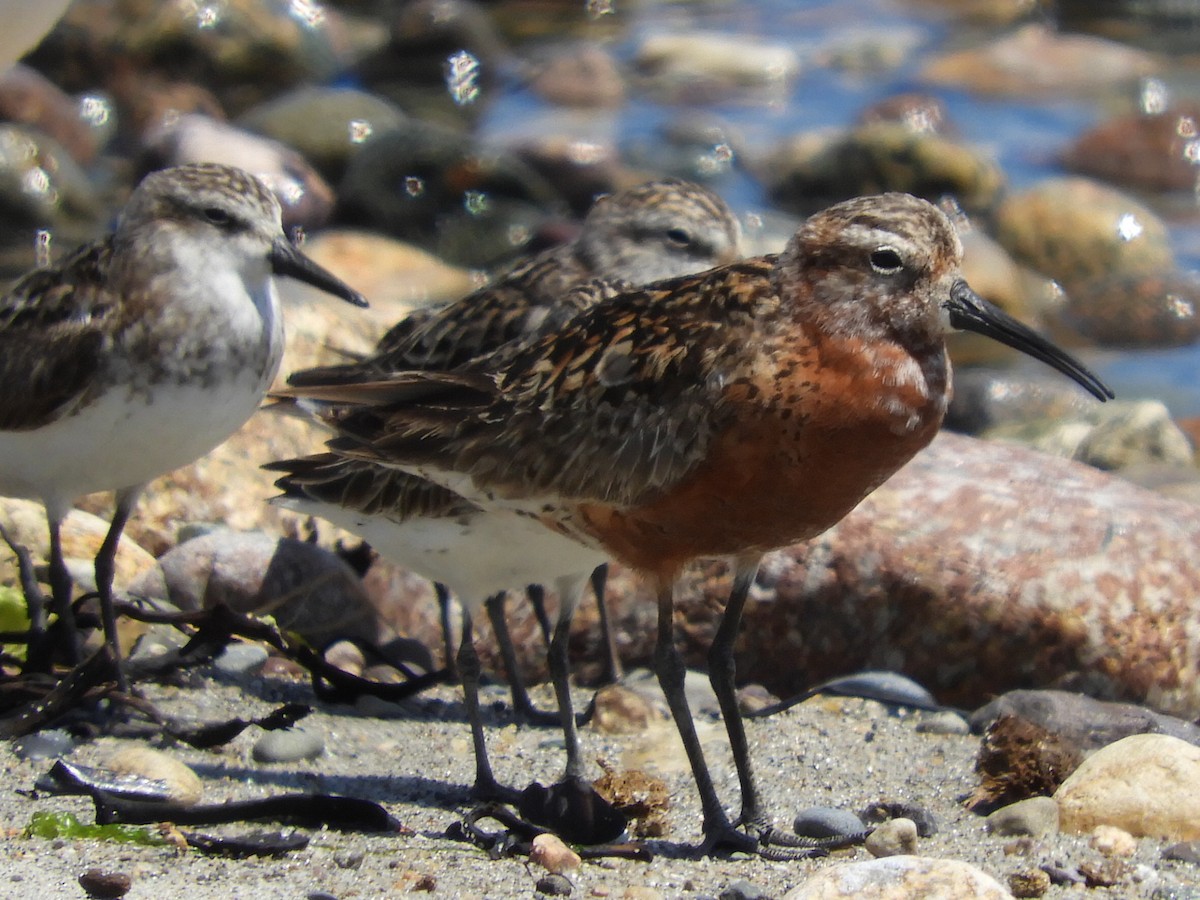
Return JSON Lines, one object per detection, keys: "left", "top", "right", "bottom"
{"left": 295, "top": 193, "right": 1112, "bottom": 858}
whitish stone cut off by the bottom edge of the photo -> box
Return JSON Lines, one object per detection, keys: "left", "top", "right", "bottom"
{"left": 782, "top": 856, "right": 1012, "bottom": 900}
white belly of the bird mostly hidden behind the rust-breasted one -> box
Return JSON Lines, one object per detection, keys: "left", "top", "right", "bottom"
{"left": 277, "top": 498, "right": 606, "bottom": 612}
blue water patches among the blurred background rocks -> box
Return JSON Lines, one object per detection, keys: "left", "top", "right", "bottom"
{"left": 482, "top": 0, "right": 1200, "bottom": 415}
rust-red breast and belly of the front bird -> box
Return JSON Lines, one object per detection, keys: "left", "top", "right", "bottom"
{"left": 575, "top": 336, "right": 947, "bottom": 577}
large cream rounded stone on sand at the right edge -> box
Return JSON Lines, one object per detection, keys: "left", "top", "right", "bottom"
{"left": 1055, "top": 734, "right": 1200, "bottom": 841}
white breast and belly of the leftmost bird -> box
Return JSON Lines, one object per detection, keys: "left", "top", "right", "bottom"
{"left": 0, "top": 268, "right": 283, "bottom": 515}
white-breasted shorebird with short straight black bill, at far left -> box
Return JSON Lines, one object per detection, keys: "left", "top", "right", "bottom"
{"left": 0, "top": 164, "right": 366, "bottom": 689}
